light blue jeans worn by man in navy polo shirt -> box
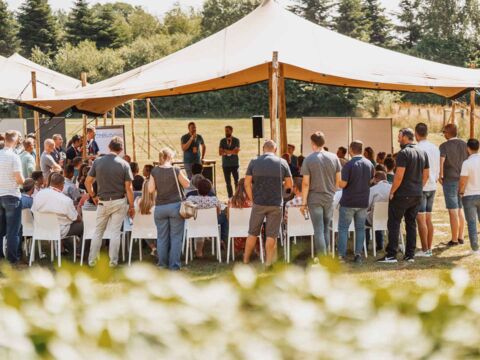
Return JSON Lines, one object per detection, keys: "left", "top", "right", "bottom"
{"left": 338, "top": 206, "right": 367, "bottom": 256}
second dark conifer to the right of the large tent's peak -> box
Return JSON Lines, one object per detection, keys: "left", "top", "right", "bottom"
{"left": 334, "top": 0, "right": 369, "bottom": 41}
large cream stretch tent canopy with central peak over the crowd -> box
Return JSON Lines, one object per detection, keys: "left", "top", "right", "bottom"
{"left": 14, "top": 0, "right": 480, "bottom": 114}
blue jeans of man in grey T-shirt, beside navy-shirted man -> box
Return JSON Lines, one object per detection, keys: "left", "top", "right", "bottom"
{"left": 308, "top": 203, "right": 333, "bottom": 254}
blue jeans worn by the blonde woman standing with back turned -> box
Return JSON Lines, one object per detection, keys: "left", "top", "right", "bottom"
{"left": 154, "top": 202, "right": 185, "bottom": 270}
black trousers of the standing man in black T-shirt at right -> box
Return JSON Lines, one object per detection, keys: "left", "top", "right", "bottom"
{"left": 387, "top": 196, "right": 422, "bottom": 257}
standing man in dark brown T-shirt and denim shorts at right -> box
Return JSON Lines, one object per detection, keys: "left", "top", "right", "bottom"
{"left": 439, "top": 124, "right": 468, "bottom": 246}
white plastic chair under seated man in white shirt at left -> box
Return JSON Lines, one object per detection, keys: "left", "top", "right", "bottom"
{"left": 29, "top": 212, "right": 69, "bottom": 267}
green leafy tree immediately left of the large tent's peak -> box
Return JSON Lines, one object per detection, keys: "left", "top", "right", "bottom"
{"left": 202, "top": 0, "right": 261, "bottom": 36}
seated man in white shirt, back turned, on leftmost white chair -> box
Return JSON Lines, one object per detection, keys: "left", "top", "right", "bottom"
{"left": 32, "top": 173, "right": 83, "bottom": 239}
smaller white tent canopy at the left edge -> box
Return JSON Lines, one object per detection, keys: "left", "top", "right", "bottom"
{"left": 0, "top": 54, "right": 81, "bottom": 101}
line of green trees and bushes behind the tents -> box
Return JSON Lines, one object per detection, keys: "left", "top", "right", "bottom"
{"left": 0, "top": 0, "right": 480, "bottom": 117}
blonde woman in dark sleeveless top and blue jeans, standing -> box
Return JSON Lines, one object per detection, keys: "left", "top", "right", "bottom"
{"left": 148, "top": 148, "right": 190, "bottom": 270}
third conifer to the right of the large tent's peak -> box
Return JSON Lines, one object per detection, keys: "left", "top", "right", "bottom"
{"left": 363, "top": 0, "right": 392, "bottom": 47}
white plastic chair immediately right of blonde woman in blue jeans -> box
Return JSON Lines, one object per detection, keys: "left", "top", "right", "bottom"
{"left": 185, "top": 207, "right": 222, "bottom": 264}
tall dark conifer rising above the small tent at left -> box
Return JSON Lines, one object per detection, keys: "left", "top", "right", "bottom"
{"left": 18, "top": 0, "right": 58, "bottom": 56}
